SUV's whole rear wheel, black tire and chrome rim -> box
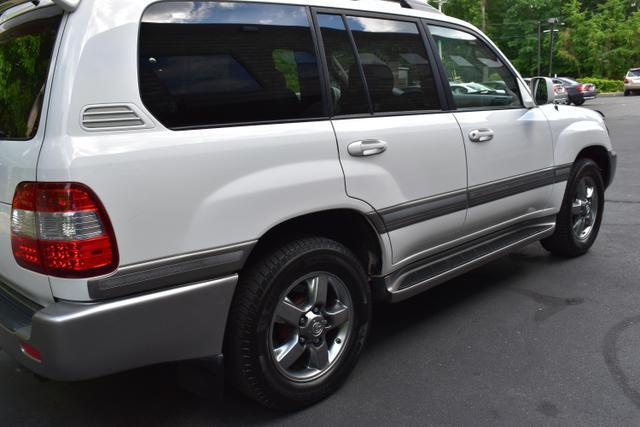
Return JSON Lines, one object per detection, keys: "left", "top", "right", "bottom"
{"left": 225, "top": 237, "right": 371, "bottom": 410}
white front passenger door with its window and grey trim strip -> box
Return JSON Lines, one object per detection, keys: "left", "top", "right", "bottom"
{"left": 428, "top": 24, "right": 555, "bottom": 234}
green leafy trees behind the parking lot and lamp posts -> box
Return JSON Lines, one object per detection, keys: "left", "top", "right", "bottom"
{"left": 445, "top": 0, "right": 640, "bottom": 87}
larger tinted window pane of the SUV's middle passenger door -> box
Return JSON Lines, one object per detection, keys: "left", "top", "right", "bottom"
{"left": 348, "top": 16, "right": 440, "bottom": 112}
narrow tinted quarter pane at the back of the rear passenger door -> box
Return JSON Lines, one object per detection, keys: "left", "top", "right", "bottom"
{"left": 318, "top": 14, "right": 369, "bottom": 115}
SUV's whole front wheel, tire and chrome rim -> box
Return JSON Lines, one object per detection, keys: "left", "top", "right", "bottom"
{"left": 541, "top": 159, "right": 604, "bottom": 257}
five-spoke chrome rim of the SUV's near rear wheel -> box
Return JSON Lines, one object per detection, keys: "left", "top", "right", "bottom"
{"left": 269, "top": 272, "right": 353, "bottom": 382}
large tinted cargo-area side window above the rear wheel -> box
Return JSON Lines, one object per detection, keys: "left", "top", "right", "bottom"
{"left": 139, "top": 1, "right": 323, "bottom": 129}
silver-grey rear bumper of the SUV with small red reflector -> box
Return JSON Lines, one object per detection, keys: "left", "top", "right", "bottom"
{"left": 0, "top": 275, "right": 237, "bottom": 381}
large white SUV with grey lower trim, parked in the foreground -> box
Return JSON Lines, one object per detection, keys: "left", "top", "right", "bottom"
{"left": 0, "top": 0, "right": 616, "bottom": 409}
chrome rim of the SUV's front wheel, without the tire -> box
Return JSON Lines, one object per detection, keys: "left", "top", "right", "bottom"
{"left": 571, "top": 176, "right": 598, "bottom": 241}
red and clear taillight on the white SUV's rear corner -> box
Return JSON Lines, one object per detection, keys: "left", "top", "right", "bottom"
{"left": 11, "top": 182, "right": 118, "bottom": 278}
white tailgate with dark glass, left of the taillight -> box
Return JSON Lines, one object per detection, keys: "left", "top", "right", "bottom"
{"left": 0, "top": 2, "right": 63, "bottom": 304}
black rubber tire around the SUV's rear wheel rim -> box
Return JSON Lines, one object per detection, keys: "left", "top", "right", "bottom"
{"left": 224, "top": 237, "right": 371, "bottom": 411}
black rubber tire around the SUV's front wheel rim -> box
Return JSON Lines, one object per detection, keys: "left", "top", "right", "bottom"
{"left": 541, "top": 159, "right": 604, "bottom": 258}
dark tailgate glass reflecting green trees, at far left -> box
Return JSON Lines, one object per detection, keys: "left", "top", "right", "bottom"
{"left": 0, "top": 7, "right": 62, "bottom": 140}
